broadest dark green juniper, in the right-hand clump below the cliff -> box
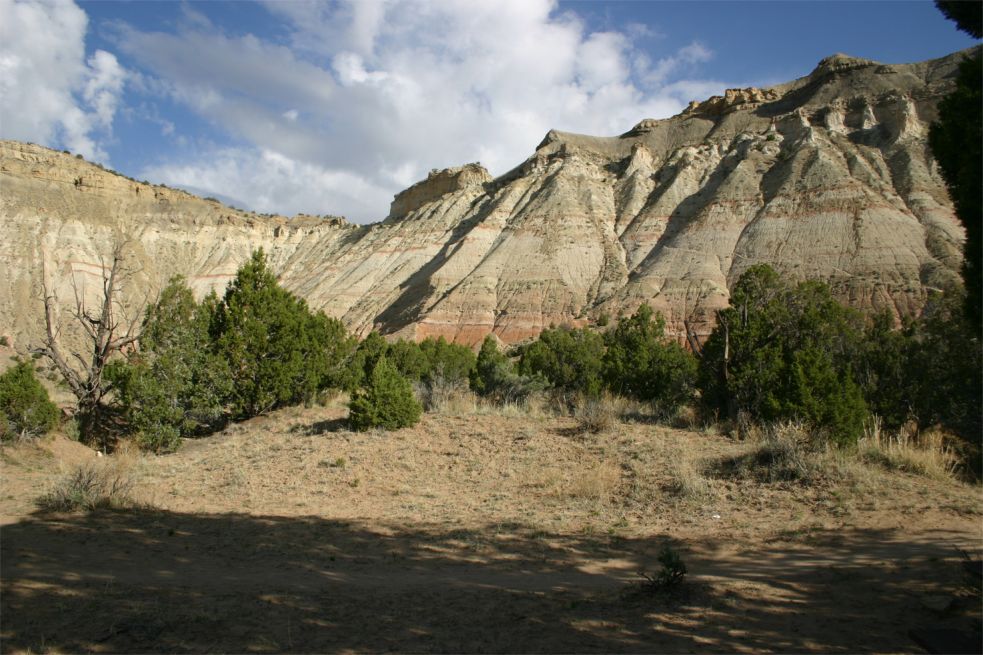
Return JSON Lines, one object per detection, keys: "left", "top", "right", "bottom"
{"left": 698, "top": 265, "right": 866, "bottom": 443}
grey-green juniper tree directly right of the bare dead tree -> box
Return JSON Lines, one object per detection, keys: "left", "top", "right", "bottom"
{"left": 108, "top": 277, "right": 232, "bottom": 453}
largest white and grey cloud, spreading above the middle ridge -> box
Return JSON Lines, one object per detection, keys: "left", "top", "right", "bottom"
{"left": 117, "top": 0, "right": 724, "bottom": 221}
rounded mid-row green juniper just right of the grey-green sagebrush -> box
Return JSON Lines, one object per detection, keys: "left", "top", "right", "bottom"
{"left": 519, "top": 327, "right": 604, "bottom": 397}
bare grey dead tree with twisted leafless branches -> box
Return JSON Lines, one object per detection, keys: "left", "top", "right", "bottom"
{"left": 32, "top": 243, "right": 142, "bottom": 449}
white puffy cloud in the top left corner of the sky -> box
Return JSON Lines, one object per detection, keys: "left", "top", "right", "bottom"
{"left": 0, "top": 0, "right": 126, "bottom": 161}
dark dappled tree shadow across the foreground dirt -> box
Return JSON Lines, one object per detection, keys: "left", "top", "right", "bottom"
{"left": 0, "top": 510, "right": 978, "bottom": 652}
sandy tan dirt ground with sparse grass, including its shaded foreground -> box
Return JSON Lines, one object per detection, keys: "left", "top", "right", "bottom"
{"left": 0, "top": 407, "right": 983, "bottom": 652}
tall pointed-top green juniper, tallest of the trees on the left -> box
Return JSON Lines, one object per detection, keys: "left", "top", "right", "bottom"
{"left": 214, "top": 250, "right": 326, "bottom": 418}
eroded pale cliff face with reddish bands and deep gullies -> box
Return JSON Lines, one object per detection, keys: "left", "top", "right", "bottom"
{"left": 0, "top": 53, "right": 963, "bottom": 354}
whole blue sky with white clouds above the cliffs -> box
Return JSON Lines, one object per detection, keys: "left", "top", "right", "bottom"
{"left": 0, "top": 0, "right": 977, "bottom": 223}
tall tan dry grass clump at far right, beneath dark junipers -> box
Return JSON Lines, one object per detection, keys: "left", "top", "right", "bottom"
{"left": 857, "top": 417, "right": 959, "bottom": 480}
